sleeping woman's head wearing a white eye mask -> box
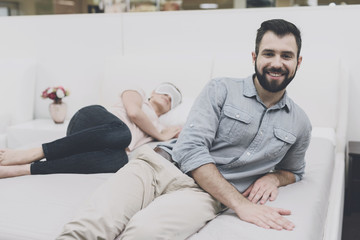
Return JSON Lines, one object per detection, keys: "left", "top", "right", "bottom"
{"left": 150, "top": 82, "right": 182, "bottom": 115}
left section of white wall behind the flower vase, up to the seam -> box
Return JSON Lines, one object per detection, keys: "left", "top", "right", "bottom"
{"left": 0, "top": 14, "right": 123, "bottom": 118}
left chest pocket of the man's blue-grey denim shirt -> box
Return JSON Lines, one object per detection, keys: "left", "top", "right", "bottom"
{"left": 218, "top": 105, "right": 252, "bottom": 143}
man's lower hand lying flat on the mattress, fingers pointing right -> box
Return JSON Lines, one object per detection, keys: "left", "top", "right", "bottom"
{"left": 235, "top": 202, "right": 295, "bottom": 231}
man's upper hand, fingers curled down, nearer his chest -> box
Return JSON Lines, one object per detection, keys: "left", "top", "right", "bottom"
{"left": 243, "top": 174, "right": 280, "bottom": 204}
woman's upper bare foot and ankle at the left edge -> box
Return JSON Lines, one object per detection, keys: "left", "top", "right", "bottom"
{"left": 0, "top": 147, "right": 44, "bottom": 166}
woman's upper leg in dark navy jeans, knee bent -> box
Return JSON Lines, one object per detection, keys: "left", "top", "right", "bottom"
{"left": 42, "top": 105, "right": 131, "bottom": 161}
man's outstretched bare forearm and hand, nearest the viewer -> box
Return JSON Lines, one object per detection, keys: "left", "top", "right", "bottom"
{"left": 191, "top": 163, "right": 295, "bottom": 230}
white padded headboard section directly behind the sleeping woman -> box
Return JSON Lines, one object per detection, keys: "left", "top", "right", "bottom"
{"left": 101, "top": 55, "right": 212, "bottom": 106}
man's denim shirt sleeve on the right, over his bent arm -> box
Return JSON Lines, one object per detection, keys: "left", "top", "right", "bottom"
{"left": 275, "top": 116, "right": 312, "bottom": 182}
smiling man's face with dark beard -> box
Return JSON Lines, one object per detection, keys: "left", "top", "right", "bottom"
{"left": 252, "top": 31, "right": 302, "bottom": 93}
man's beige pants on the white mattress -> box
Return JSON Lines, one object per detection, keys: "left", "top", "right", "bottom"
{"left": 57, "top": 146, "right": 223, "bottom": 240}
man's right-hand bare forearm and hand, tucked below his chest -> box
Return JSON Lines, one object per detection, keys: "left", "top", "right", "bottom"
{"left": 243, "top": 170, "right": 295, "bottom": 204}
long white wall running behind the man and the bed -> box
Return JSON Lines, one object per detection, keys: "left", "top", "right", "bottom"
{"left": 0, "top": 5, "right": 360, "bottom": 140}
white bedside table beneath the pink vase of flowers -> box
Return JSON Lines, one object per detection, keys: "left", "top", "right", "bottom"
{"left": 7, "top": 119, "right": 69, "bottom": 149}
